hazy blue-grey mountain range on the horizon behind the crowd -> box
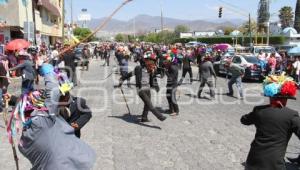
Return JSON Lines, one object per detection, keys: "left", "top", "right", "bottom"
{"left": 79, "top": 15, "right": 244, "bottom": 34}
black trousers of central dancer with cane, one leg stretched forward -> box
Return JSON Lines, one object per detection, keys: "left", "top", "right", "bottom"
{"left": 138, "top": 89, "right": 163, "bottom": 119}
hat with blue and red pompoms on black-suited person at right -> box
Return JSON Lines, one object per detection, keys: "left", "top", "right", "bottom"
{"left": 263, "top": 73, "right": 297, "bottom": 100}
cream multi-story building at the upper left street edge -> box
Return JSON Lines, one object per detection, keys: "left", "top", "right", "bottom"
{"left": 0, "top": 0, "right": 64, "bottom": 44}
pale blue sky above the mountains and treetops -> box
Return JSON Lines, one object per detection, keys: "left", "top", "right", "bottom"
{"left": 65, "top": 0, "right": 296, "bottom": 21}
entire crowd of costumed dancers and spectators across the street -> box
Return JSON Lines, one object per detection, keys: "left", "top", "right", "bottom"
{"left": 0, "top": 39, "right": 300, "bottom": 169}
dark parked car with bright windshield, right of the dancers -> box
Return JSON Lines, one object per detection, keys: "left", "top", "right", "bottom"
{"left": 214, "top": 54, "right": 263, "bottom": 80}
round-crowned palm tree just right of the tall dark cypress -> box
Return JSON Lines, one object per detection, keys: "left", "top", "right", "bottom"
{"left": 279, "top": 6, "right": 294, "bottom": 29}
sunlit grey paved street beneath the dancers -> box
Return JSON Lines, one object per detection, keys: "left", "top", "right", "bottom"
{"left": 0, "top": 57, "right": 300, "bottom": 170}
